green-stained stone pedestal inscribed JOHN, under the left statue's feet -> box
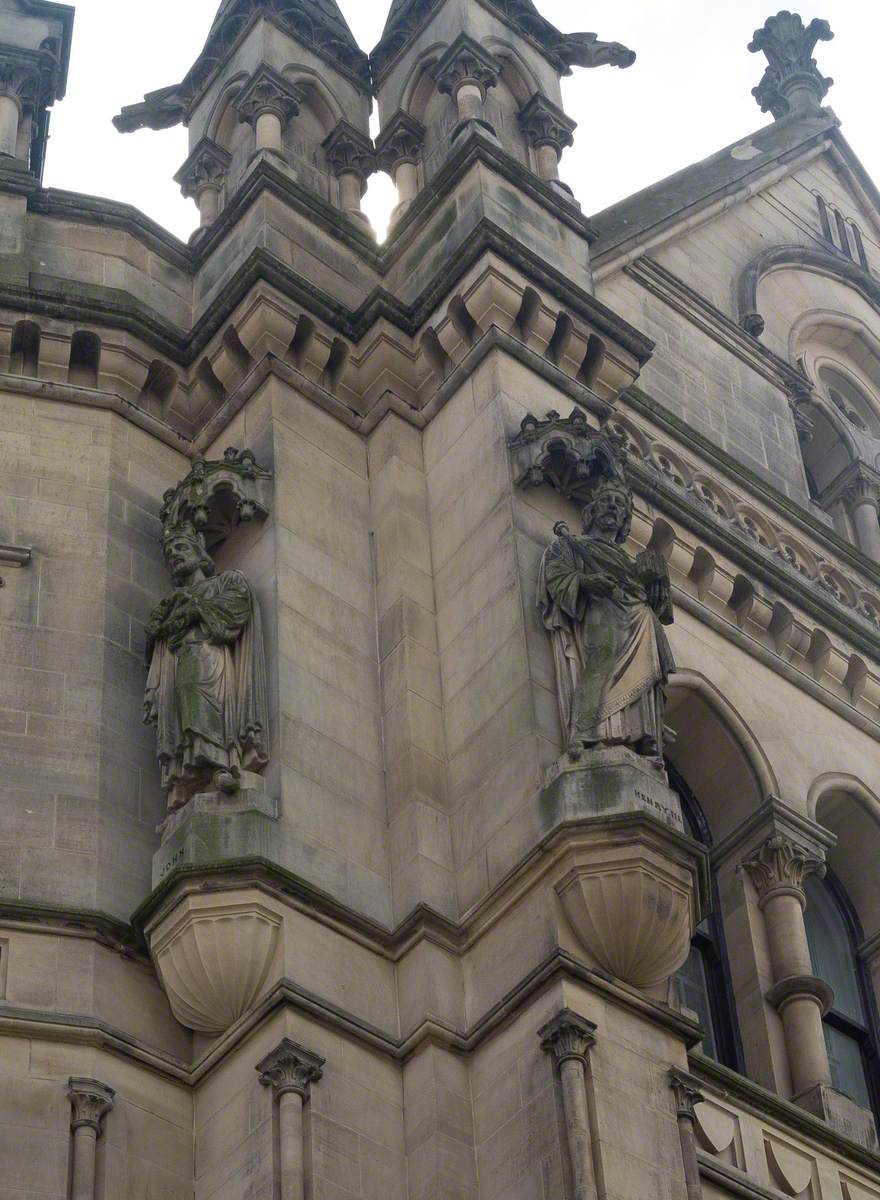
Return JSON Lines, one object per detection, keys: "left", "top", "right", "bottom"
{"left": 152, "top": 772, "right": 279, "bottom": 888}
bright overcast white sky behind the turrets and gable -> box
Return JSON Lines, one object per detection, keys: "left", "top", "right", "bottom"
{"left": 46, "top": 0, "right": 880, "bottom": 238}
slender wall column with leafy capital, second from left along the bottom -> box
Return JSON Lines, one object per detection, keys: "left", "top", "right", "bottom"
{"left": 257, "top": 1038, "right": 324, "bottom": 1200}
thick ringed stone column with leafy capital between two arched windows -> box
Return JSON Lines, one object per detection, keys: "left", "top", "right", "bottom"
{"left": 742, "top": 834, "right": 833, "bottom": 1098}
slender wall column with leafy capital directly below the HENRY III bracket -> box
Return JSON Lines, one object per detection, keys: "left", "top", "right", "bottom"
{"left": 538, "top": 1009, "right": 598, "bottom": 1200}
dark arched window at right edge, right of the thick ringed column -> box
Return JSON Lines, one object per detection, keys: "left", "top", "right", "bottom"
{"left": 804, "top": 872, "right": 880, "bottom": 1116}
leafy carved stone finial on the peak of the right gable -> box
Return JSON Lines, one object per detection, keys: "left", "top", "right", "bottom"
{"left": 748, "top": 11, "right": 834, "bottom": 120}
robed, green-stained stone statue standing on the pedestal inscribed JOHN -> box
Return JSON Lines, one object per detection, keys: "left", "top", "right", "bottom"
{"left": 144, "top": 524, "right": 269, "bottom": 810}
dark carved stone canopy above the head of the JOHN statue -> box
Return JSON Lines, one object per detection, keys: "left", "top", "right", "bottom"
{"left": 160, "top": 448, "right": 273, "bottom": 552}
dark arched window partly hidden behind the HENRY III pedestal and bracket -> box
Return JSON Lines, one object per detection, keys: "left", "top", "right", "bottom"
{"left": 666, "top": 762, "right": 743, "bottom": 1072}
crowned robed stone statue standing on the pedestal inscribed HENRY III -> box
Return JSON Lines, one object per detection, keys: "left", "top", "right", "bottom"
{"left": 538, "top": 480, "right": 675, "bottom": 767}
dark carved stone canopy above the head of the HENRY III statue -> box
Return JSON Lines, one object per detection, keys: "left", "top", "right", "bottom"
{"left": 509, "top": 408, "right": 627, "bottom": 504}
